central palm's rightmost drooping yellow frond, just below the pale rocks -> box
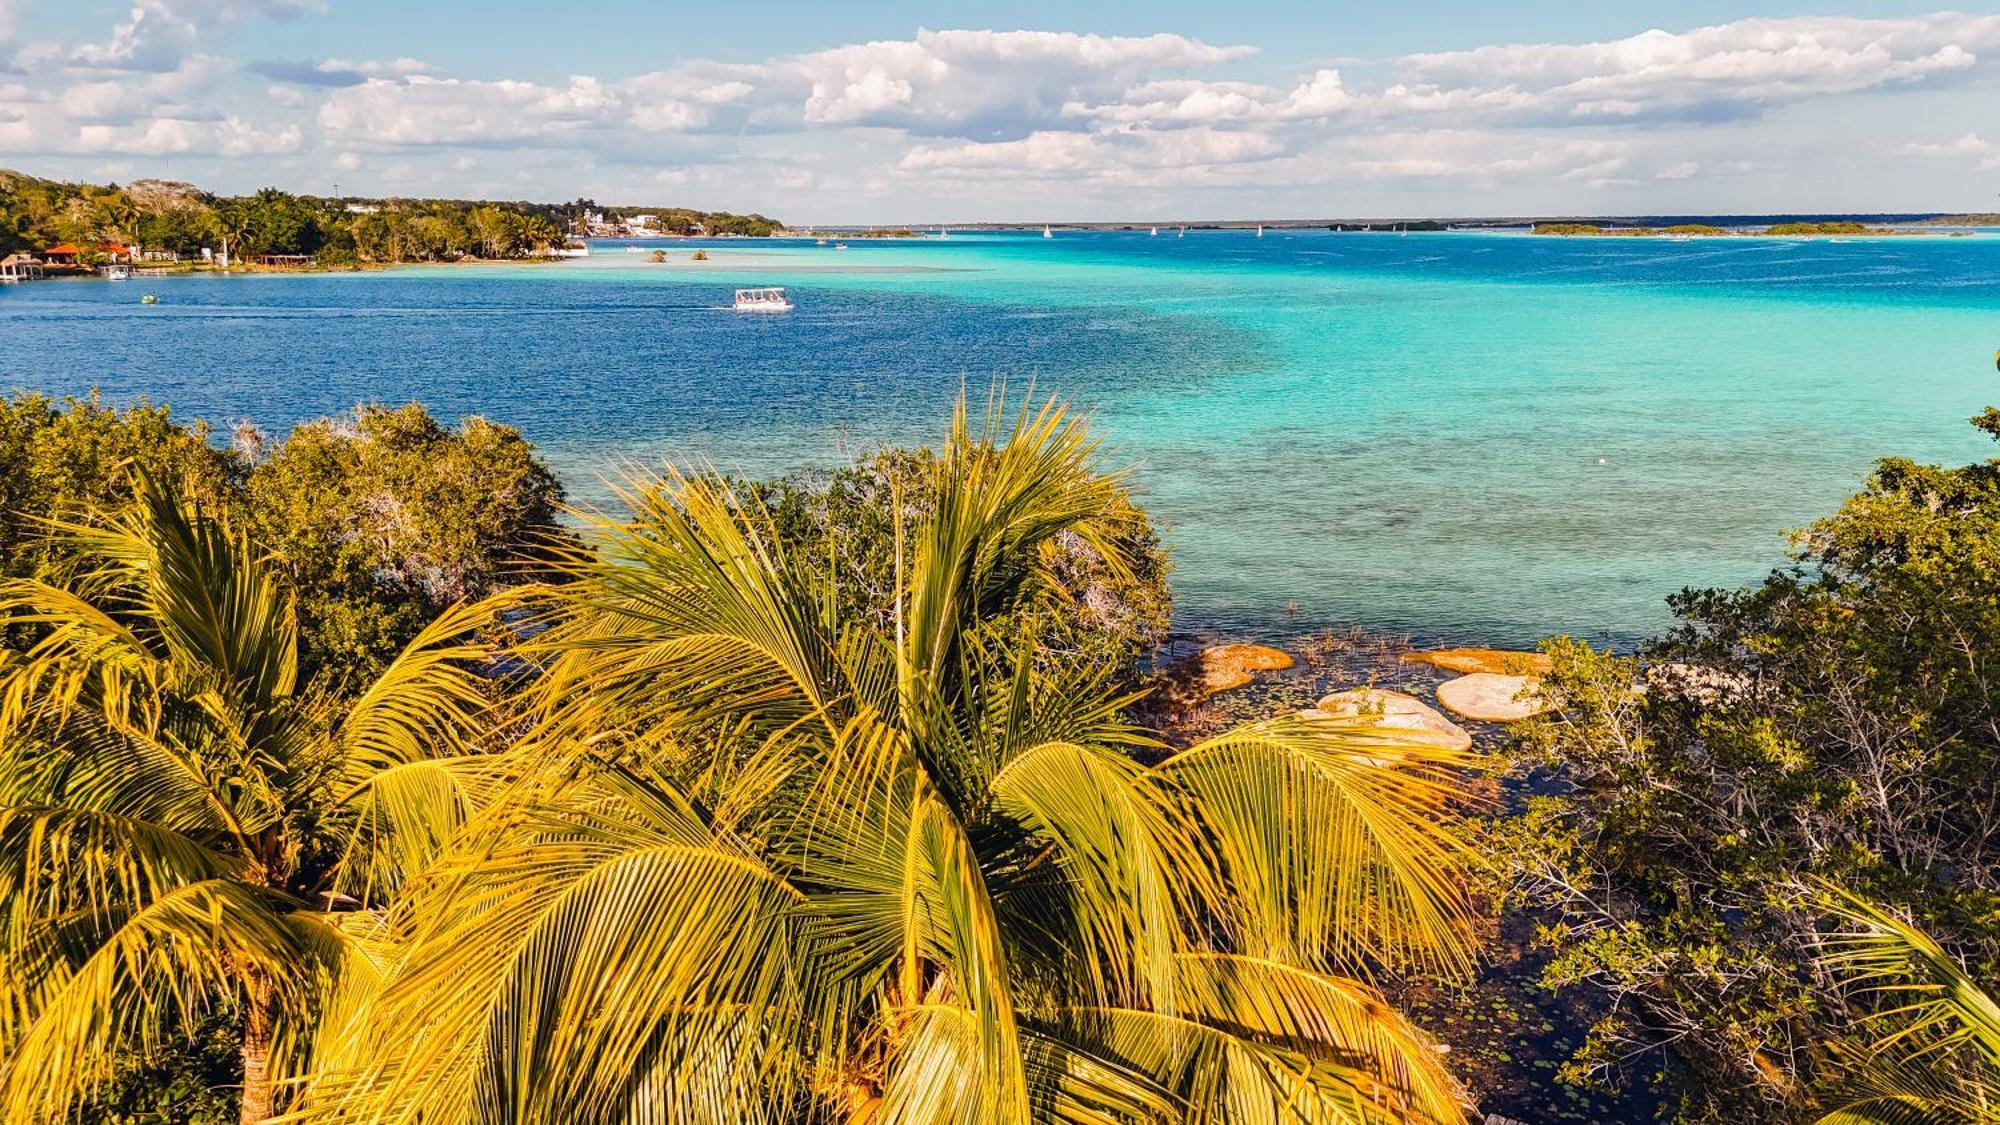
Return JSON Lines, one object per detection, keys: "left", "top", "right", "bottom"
{"left": 1158, "top": 715, "right": 1476, "bottom": 973}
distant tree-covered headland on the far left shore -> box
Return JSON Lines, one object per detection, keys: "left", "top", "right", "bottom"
{"left": 0, "top": 170, "right": 776, "bottom": 266}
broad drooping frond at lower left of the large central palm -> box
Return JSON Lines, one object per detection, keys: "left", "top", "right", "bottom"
{"left": 312, "top": 752, "right": 810, "bottom": 1123}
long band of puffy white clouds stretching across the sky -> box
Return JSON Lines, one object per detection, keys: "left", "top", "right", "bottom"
{"left": 0, "top": 11, "right": 2000, "bottom": 206}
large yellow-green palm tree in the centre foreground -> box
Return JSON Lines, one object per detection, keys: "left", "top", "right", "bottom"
{"left": 308, "top": 404, "right": 1468, "bottom": 1125}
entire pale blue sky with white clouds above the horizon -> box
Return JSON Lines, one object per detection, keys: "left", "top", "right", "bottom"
{"left": 0, "top": 0, "right": 2000, "bottom": 224}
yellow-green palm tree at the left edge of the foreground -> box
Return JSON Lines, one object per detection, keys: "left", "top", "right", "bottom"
{"left": 0, "top": 482, "right": 500, "bottom": 1123}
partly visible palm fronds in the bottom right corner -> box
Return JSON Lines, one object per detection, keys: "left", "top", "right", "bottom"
{"left": 1820, "top": 891, "right": 2000, "bottom": 1125}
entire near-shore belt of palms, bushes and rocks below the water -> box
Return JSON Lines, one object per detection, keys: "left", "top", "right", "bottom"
{"left": 0, "top": 380, "right": 2000, "bottom": 1125}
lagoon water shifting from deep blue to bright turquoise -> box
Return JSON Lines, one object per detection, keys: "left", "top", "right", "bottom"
{"left": 0, "top": 230, "right": 2000, "bottom": 643}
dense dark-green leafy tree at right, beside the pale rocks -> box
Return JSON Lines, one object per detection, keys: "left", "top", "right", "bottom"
{"left": 1496, "top": 410, "right": 2000, "bottom": 1121}
